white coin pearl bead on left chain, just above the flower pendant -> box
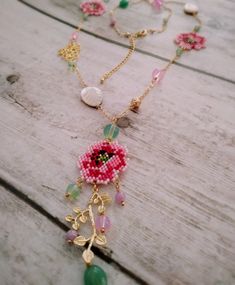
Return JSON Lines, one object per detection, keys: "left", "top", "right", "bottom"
{"left": 81, "top": 87, "right": 103, "bottom": 107}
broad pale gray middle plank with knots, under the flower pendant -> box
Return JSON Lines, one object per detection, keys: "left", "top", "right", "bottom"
{"left": 0, "top": 1, "right": 235, "bottom": 285}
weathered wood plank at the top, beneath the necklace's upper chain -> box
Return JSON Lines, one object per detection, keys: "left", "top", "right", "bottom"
{"left": 24, "top": 0, "right": 235, "bottom": 81}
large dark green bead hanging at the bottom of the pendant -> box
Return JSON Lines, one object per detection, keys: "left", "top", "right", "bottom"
{"left": 84, "top": 265, "right": 108, "bottom": 285}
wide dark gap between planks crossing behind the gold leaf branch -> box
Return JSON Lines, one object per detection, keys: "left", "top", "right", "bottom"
{"left": 0, "top": 177, "right": 149, "bottom": 285}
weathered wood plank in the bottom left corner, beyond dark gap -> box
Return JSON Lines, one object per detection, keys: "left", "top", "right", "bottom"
{"left": 0, "top": 184, "right": 136, "bottom": 285}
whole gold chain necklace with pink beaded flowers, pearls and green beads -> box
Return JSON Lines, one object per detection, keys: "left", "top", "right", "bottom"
{"left": 58, "top": 0, "right": 205, "bottom": 285}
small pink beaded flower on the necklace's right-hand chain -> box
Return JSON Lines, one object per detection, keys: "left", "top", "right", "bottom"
{"left": 175, "top": 33, "right": 206, "bottom": 50}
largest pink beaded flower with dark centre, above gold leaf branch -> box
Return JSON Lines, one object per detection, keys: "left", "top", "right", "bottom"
{"left": 78, "top": 140, "right": 127, "bottom": 184}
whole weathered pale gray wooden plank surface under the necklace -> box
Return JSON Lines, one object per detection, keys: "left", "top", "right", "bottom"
{"left": 0, "top": 0, "right": 235, "bottom": 285}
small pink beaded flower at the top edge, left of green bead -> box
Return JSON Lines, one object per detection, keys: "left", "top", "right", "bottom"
{"left": 80, "top": 0, "right": 106, "bottom": 16}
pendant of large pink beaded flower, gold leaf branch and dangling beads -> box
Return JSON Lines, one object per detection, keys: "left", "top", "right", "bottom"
{"left": 65, "top": 124, "right": 128, "bottom": 265}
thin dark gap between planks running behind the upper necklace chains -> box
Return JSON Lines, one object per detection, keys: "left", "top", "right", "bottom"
{"left": 17, "top": 0, "right": 235, "bottom": 84}
